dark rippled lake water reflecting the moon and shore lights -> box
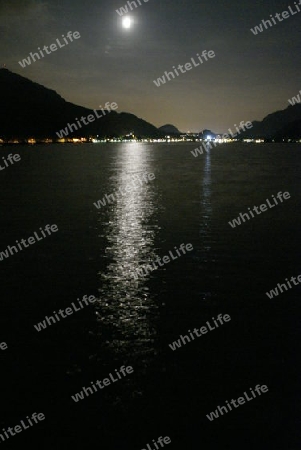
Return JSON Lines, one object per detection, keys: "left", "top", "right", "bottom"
{"left": 0, "top": 144, "right": 301, "bottom": 450}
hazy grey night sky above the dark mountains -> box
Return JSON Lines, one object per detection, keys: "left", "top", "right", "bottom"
{"left": 0, "top": 0, "right": 301, "bottom": 132}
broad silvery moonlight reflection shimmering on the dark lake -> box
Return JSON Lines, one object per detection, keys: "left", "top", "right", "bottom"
{"left": 98, "top": 145, "right": 159, "bottom": 366}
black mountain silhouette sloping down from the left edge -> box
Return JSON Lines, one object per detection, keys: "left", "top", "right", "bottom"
{"left": 0, "top": 68, "right": 162, "bottom": 139}
